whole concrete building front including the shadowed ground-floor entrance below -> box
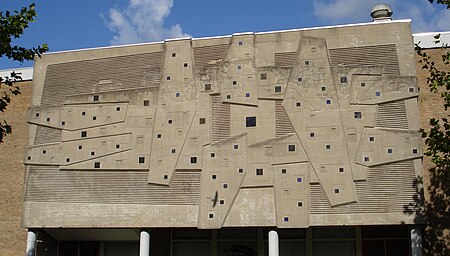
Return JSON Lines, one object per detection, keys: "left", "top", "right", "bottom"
{"left": 22, "top": 20, "right": 422, "bottom": 256}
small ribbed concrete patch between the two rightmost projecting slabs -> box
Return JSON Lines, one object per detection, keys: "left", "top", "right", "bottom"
{"left": 375, "top": 101, "right": 408, "bottom": 129}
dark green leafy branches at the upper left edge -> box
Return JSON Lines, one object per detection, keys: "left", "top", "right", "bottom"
{"left": 0, "top": 4, "right": 48, "bottom": 143}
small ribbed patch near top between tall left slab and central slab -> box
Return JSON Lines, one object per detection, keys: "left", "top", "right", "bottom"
{"left": 194, "top": 44, "right": 228, "bottom": 68}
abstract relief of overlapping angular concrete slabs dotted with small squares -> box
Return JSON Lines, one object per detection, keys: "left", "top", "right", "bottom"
{"left": 25, "top": 24, "right": 422, "bottom": 228}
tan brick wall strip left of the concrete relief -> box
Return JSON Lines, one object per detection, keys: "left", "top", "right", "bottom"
{"left": 0, "top": 82, "right": 32, "bottom": 256}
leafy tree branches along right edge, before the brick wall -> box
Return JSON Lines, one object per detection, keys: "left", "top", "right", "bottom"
{"left": 410, "top": 0, "right": 450, "bottom": 255}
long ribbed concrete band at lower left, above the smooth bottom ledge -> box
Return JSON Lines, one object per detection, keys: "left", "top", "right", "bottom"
{"left": 25, "top": 167, "right": 200, "bottom": 205}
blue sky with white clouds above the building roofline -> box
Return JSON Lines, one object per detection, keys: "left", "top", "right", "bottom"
{"left": 0, "top": 0, "right": 450, "bottom": 69}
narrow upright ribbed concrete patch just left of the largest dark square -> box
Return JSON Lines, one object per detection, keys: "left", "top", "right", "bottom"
{"left": 211, "top": 95, "right": 231, "bottom": 142}
